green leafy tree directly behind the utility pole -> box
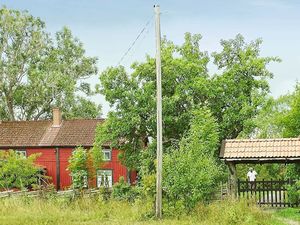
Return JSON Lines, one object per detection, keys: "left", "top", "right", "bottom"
{"left": 96, "top": 33, "right": 209, "bottom": 168}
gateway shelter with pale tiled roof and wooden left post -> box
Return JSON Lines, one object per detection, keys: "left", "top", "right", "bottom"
{"left": 220, "top": 138, "right": 300, "bottom": 205}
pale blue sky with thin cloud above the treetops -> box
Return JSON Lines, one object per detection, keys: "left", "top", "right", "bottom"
{"left": 0, "top": 0, "right": 300, "bottom": 116}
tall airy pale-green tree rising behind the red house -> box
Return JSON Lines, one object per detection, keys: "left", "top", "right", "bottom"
{"left": 0, "top": 7, "right": 100, "bottom": 120}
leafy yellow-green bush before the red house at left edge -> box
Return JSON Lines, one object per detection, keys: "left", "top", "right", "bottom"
{"left": 0, "top": 150, "right": 40, "bottom": 190}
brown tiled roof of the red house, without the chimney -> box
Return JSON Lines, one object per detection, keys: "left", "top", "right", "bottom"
{"left": 0, "top": 119, "right": 104, "bottom": 148}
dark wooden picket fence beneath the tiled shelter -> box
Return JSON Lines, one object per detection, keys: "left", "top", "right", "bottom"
{"left": 238, "top": 179, "right": 294, "bottom": 207}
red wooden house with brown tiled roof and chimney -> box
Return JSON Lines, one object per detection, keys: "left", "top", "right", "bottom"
{"left": 0, "top": 108, "right": 136, "bottom": 189}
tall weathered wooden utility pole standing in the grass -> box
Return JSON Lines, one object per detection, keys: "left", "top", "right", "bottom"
{"left": 154, "top": 5, "right": 162, "bottom": 218}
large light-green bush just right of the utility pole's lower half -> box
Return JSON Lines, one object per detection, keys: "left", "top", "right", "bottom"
{"left": 163, "top": 109, "right": 221, "bottom": 210}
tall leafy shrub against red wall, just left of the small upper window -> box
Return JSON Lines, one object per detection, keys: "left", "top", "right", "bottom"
{"left": 68, "top": 147, "right": 102, "bottom": 189}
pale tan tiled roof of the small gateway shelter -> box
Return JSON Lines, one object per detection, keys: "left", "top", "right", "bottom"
{"left": 220, "top": 138, "right": 300, "bottom": 161}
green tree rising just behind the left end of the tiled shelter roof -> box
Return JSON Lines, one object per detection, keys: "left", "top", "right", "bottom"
{"left": 208, "top": 35, "right": 280, "bottom": 140}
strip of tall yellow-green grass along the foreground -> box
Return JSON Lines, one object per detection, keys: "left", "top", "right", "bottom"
{"left": 0, "top": 197, "right": 292, "bottom": 225}
